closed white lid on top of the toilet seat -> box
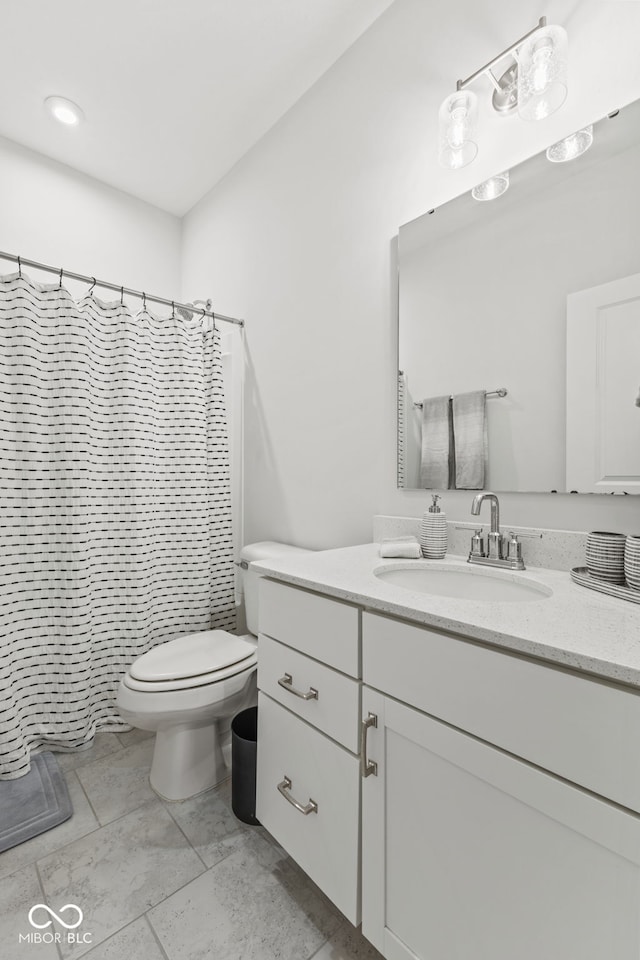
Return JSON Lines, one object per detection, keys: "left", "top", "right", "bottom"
{"left": 129, "top": 630, "right": 256, "bottom": 683}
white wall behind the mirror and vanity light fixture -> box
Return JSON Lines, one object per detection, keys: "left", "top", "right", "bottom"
{"left": 183, "top": 0, "right": 640, "bottom": 547}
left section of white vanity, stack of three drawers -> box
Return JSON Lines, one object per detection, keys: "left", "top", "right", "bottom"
{"left": 256, "top": 579, "right": 362, "bottom": 924}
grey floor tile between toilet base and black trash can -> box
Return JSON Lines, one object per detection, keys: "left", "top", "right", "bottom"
{"left": 165, "top": 780, "right": 261, "bottom": 867}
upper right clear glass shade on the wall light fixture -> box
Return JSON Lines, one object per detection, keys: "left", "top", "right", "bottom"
{"left": 517, "top": 26, "right": 569, "bottom": 120}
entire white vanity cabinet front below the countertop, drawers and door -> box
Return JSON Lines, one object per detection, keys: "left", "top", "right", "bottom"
{"left": 257, "top": 568, "right": 640, "bottom": 960}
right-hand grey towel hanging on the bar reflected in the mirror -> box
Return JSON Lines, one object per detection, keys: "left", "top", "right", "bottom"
{"left": 452, "top": 390, "right": 488, "bottom": 490}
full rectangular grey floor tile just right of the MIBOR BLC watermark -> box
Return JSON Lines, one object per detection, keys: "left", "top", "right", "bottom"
{"left": 38, "top": 800, "right": 204, "bottom": 957}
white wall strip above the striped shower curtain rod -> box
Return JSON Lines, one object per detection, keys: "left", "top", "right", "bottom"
{"left": 0, "top": 138, "right": 181, "bottom": 302}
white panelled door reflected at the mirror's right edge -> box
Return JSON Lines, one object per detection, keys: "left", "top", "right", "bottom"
{"left": 568, "top": 273, "right": 640, "bottom": 493}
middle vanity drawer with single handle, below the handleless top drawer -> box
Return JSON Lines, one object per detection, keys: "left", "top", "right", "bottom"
{"left": 258, "top": 634, "right": 361, "bottom": 753}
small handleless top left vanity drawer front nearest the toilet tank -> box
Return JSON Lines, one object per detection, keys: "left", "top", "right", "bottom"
{"left": 259, "top": 578, "right": 360, "bottom": 677}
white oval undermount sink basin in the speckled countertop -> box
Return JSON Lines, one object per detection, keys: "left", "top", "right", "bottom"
{"left": 373, "top": 560, "right": 553, "bottom": 603}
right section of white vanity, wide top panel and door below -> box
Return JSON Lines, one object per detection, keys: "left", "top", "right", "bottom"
{"left": 362, "top": 613, "right": 640, "bottom": 960}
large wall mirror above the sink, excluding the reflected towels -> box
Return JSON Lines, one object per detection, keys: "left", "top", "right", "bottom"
{"left": 398, "top": 101, "right": 640, "bottom": 493}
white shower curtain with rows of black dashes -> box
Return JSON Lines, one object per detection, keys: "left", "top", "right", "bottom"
{"left": 0, "top": 274, "right": 235, "bottom": 779}
